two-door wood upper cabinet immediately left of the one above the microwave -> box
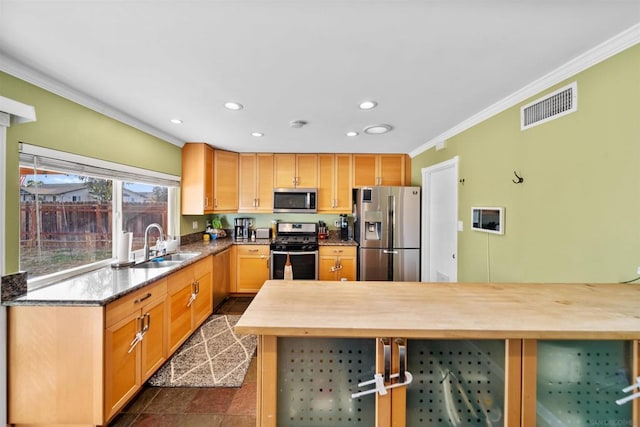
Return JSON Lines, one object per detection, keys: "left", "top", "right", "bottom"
{"left": 238, "top": 153, "right": 273, "bottom": 213}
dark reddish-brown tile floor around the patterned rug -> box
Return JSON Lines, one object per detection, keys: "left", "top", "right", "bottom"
{"left": 109, "top": 297, "right": 257, "bottom": 427}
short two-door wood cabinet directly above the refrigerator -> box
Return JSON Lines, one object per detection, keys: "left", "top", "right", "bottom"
{"left": 353, "top": 154, "right": 411, "bottom": 187}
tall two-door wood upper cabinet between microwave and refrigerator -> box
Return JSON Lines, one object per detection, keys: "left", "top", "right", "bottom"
{"left": 318, "top": 154, "right": 353, "bottom": 213}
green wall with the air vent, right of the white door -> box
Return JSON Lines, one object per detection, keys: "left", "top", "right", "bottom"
{"left": 412, "top": 45, "right": 640, "bottom": 282}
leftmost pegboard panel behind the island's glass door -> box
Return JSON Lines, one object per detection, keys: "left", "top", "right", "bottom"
{"left": 277, "top": 338, "right": 376, "bottom": 427}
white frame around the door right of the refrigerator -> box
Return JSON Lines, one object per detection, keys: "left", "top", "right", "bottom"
{"left": 420, "top": 156, "right": 459, "bottom": 282}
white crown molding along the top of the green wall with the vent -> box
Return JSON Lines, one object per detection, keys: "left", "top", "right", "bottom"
{"left": 409, "top": 24, "right": 640, "bottom": 158}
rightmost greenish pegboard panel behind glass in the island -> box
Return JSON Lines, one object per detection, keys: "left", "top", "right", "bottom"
{"left": 536, "top": 341, "right": 635, "bottom": 427}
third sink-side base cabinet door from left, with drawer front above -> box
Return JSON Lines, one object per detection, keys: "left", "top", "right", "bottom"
{"left": 167, "top": 267, "right": 195, "bottom": 353}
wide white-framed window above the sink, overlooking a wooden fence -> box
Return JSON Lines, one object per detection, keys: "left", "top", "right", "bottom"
{"left": 20, "top": 144, "right": 179, "bottom": 289}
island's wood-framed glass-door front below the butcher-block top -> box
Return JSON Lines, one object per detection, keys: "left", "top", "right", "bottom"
{"left": 258, "top": 336, "right": 640, "bottom": 427}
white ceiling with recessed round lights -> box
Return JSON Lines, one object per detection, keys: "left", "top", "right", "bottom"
{"left": 0, "top": 0, "right": 640, "bottom": 153}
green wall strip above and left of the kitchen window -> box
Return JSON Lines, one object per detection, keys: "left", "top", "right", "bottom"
{"left": 0, "top": 72, "right": 182, "bottom": 273}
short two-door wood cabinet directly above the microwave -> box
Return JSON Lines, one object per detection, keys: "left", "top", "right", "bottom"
{"left": 273, "top": 154, "right": 318, "bottom": 188}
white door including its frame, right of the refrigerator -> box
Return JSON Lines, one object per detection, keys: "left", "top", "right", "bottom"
{"left": 421, "top": 156, "right": 458, "bottom": 282}
